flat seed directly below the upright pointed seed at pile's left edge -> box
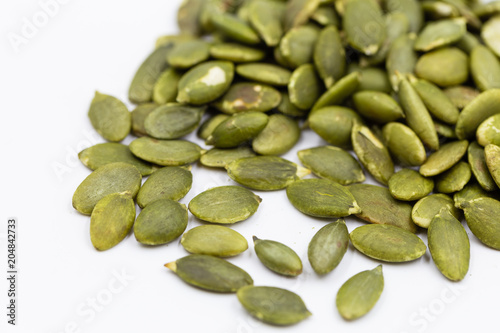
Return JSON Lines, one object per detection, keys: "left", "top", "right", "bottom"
{"left": 78, "top": 143, "right": 155, "bottom": 176}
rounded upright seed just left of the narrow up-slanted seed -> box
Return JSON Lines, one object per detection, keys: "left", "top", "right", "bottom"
{"left": 288, "top": 64, "right": 323, "bottom": 110}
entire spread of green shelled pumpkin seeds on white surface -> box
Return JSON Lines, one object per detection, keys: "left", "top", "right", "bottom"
{"left": 73, "top": 0, "right": 500, "bottom": 325}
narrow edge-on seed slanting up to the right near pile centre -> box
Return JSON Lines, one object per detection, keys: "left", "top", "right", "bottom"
{"left": 311, "top": 72, "right": 361, "bottom": 114}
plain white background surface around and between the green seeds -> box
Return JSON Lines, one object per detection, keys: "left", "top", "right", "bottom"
{"left": 0, "top": 0, "right": 500, "bottom": 333}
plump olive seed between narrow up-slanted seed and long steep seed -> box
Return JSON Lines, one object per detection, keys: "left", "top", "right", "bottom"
{"left": 352, "top": 91, "right": 406, "bottom": 124}
